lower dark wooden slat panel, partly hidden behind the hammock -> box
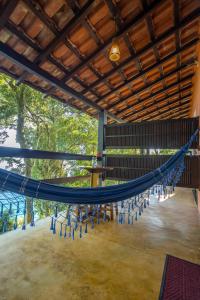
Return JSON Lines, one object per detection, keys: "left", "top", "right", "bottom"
{"left": 105, "top": 155, "right": 200, "bottom": 188}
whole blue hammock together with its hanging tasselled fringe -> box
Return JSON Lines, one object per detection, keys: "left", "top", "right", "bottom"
{"left": 0, "top": 130, "right": 199, "bottom": 240}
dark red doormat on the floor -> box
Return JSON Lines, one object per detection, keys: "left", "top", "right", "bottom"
{"left": 159, "top": 255, "right": 200, "bottom": 300}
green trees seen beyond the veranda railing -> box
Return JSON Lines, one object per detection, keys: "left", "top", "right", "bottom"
{"left": 0, "top": 75, "right": 97, "bottom": 220}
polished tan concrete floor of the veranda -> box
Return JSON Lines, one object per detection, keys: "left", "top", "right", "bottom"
{"left": 0, "top": 189, "right": 200, "bottom": 300}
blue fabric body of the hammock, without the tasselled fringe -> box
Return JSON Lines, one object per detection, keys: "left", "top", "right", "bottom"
{"left": 0, "top": 130, "right": 198, "bottom": 205}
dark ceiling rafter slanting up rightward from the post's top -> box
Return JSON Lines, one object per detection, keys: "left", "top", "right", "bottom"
{"left": 106, "top": 59, "right": 195, "bottom": 110}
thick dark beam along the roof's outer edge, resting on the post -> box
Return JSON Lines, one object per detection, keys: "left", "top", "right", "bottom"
{"left": 0, "top": 42, "right": 123, "bottom": 122}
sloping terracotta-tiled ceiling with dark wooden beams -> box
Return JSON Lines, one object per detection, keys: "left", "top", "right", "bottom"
{"left": 0, "top": 0, "right": 200, "bottom": 122}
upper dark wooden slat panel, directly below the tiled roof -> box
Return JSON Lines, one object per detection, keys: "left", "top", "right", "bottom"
{"left": 105, "top": 118, "right": 199, "bottom": 149}
